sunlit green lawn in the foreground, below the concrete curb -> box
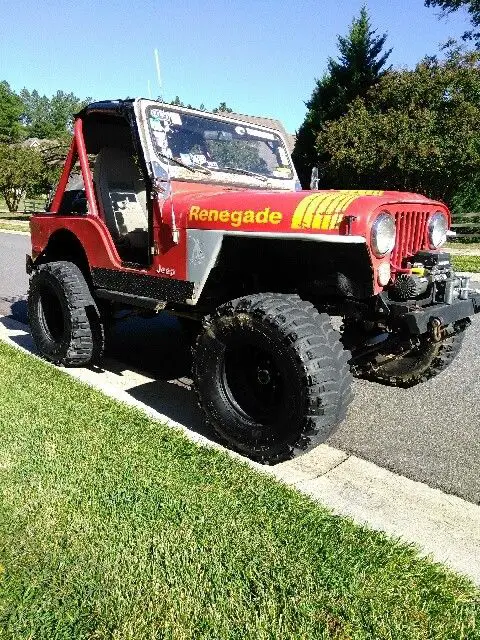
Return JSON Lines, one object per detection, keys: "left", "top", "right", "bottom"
{"left": 0, "top": 342, "right": 480, "bottom": 640}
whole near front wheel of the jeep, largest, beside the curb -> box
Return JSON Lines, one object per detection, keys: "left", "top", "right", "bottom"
{"left": 193, "top": 293, "right": 352, "bottom": 463}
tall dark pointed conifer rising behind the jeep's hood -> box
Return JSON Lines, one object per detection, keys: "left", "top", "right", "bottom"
{"left": 293, "top": 7, "right": 391, "bottom": 187}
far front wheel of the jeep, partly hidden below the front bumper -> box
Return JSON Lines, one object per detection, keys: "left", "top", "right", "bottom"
{"left": 355, "top": 324, "right": 465, "bottom": 388}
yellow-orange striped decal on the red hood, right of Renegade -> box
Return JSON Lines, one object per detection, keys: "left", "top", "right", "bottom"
{"left": 292, "top": 190, "right": 383, "bottom": 229}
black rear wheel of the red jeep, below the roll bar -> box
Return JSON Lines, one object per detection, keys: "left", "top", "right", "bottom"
{"left": 28, "top": 262, "right": 104, "bottom": 367}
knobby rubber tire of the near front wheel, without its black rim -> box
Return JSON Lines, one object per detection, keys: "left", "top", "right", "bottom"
{"left": 193, "top": 293, "right": 353, "bottom": 464}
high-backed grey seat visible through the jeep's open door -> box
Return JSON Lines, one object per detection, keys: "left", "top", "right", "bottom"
{"left": 93, "top": 147, "right": 148, "bottom": 261}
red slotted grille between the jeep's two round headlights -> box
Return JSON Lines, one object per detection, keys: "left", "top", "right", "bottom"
{"left": 391, "top": 211, "right": 430, "bottom": 269}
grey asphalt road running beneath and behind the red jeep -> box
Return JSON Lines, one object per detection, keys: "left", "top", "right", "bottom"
{"left": 0, "top": 233, "right": 480, "bottom": 504}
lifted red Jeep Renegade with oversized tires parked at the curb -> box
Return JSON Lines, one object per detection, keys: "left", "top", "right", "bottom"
{"left": 27, "top": 99, "right": 480, "bottom": 463}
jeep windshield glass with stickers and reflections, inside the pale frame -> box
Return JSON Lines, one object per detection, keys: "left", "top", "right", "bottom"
{"left": 147, "top": 107, "right": 293, "bottom": 182}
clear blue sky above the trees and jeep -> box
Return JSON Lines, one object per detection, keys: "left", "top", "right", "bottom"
{"left": 0, "top": 0, "right": 469, "bottom": 133}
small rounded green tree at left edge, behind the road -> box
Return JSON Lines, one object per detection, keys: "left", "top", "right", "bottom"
{"left": 0, "top": 143, "right": 46, "bottom": 211}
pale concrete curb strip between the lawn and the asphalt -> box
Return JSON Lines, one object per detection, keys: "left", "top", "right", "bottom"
{"left": 0, "top": 316, "right": 480, "bottom": 585}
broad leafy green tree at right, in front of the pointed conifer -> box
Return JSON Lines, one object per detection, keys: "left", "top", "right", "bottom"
{"left": 317, "top": 52, "right": 480, "bottom": 202}
